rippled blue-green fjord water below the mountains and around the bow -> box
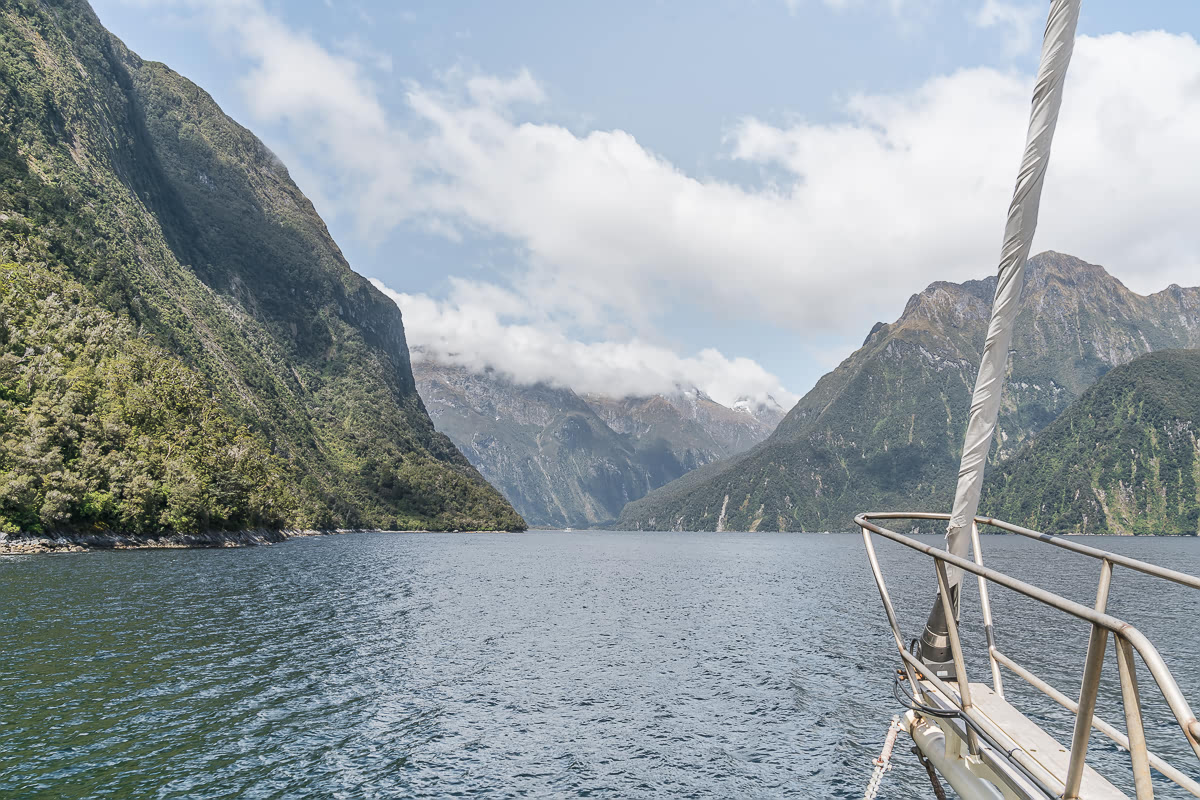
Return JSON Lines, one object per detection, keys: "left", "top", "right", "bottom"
{"left": 0, "top": 531, "right": 1200, "bottom": 798}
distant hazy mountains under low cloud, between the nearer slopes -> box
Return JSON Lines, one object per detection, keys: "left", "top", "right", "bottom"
{"left": 413, "top": 356, "right": 778, "bottom": 528}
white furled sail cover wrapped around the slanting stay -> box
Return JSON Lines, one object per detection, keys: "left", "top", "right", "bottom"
{"left": 946, "top": 0, "right": 1079, "bottom": 597}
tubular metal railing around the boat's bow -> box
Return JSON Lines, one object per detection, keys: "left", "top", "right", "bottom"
{"left": 854, "top": 512, "right": 1200, "bottom": 800}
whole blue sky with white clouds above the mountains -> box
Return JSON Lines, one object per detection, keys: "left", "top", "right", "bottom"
{"left": 92, "top": 0, "right": 1200, "bottom": 407}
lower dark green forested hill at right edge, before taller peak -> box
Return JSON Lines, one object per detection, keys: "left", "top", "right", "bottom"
{"left": 982, "top": 350, "right": 1200, "bottom": 534}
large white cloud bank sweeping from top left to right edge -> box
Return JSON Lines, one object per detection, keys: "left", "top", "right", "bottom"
{"left": 140, "top": 0, "right": 1200, "bottom": 400}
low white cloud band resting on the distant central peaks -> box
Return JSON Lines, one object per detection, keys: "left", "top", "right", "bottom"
{"left": 372, "top": 279, "right": 799, "bottom": 408}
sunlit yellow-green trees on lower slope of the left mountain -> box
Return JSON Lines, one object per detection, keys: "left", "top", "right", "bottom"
{"left": 0, "top": 264, "right": 296, "bottom": 534}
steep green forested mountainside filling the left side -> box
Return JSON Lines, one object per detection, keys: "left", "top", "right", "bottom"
{"left": 0, "top": 0, "right": 523, "bottom": 533}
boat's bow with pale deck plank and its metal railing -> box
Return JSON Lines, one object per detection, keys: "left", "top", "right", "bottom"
{"left": 854, "top": 511, "right": 1200, "bottom": 800}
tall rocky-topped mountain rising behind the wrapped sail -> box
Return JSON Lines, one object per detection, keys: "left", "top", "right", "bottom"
{"left": 618, "top": 252, "right": 1200, "bottom": 530}
